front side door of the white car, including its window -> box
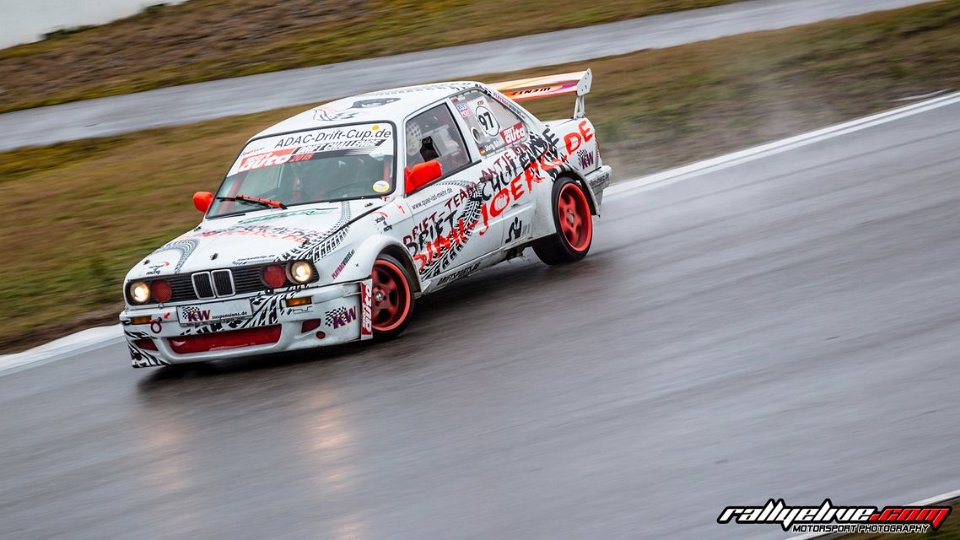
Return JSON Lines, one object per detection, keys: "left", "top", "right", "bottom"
{"left": 403, "top": 100, "right": 502, "bottom": 280}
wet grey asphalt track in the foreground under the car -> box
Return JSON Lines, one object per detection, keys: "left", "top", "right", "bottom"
{"left": 0, "top": 105, "right": 960, "bottom": 539}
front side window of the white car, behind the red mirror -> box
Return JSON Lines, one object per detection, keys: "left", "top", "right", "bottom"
{"left": 406, "top": 103, "right": 470, "bottom": 176}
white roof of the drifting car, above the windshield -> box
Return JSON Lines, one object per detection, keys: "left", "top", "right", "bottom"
{"left": 254, "top": 81, "right": 482, "bottom": 138}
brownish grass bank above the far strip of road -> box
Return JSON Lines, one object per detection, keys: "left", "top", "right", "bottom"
{"left": 0, "top": 0, "right": 733, "bottom": 112}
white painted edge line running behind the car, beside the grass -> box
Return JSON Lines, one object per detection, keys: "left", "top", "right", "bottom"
{"left": 0, "top": 92, "right": 960, "bottom": 376}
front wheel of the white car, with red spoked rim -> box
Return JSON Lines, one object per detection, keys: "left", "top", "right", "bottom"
{"left": 370, "top": 254, "right": 414, "bottom": 341}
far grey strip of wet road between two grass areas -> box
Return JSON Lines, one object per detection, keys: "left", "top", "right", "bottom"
{"left": 0, "top": 0, "right": 929, "bottom": 151}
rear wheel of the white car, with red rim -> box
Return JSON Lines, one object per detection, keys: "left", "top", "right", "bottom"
{"left": 533, "top": 178, "right": 593, "bottom": 264}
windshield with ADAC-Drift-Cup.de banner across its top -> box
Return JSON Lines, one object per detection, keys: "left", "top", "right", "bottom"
{"left": 207, "top": 122, "right": 396, "bottom": 217}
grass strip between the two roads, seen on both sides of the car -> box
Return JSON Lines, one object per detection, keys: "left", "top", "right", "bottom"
{"left": 0, "top": 1, "right": 960, "bottom": 352}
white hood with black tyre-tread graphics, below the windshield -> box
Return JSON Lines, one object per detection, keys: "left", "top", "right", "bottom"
{"left": 127, "top": 199, "right": 386, "bottom": 279}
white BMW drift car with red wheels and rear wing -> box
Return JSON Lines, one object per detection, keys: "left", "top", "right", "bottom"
{"left": 120, "top": 70, "right": 610, "bottom": 367}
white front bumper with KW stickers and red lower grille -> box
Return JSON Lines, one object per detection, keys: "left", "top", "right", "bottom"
{"left": 120, "top": 280, "right": 373, "bottom": 367}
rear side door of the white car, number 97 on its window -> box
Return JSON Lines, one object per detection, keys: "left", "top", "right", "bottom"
{"left": 451, "top": 88, "right": 542, "bottom": 247}
